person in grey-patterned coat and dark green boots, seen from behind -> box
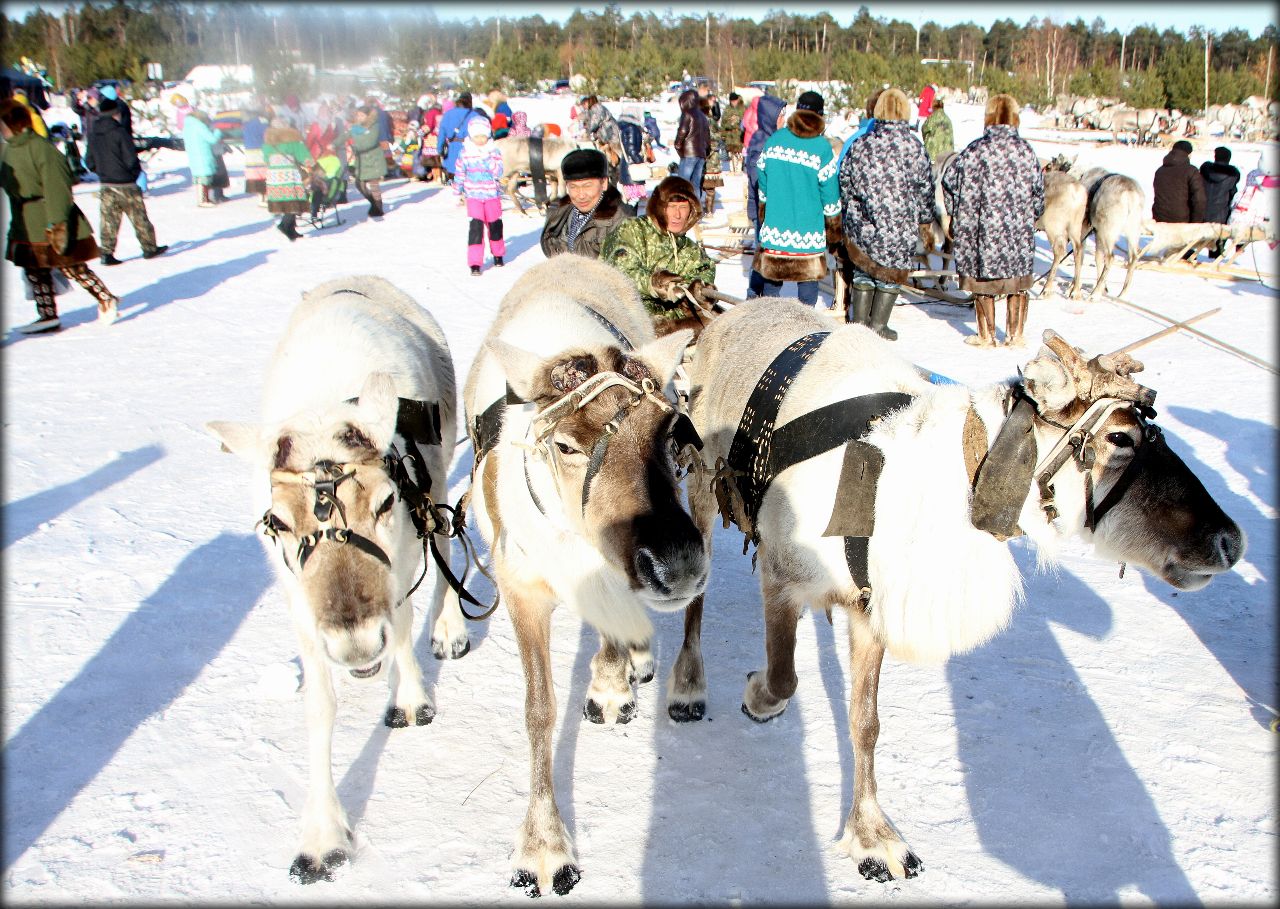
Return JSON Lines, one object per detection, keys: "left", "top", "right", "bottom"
{"left": 838, "top": 88, "right": 934, "bottom": 341}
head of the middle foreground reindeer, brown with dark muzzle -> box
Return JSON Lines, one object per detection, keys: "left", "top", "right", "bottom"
{"left": 490, "top": 330, "right": 708, "bottom": 611}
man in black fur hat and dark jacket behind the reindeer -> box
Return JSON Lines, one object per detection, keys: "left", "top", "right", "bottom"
{"left": 541, "top": 149, "right": 636, "bottom": 259}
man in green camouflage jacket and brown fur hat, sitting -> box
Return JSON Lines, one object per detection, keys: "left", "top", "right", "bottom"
{"left": 600, "top": 174, "right": 716, "bottom": 335}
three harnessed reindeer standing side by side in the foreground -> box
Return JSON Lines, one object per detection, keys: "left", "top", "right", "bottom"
{"left": 209, "top": 256, "right": 1245, "bottom": 896}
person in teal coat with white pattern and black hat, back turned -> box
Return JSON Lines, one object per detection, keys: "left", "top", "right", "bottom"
{"left": 748, "top": 91, "right": 841, "bottom": 306}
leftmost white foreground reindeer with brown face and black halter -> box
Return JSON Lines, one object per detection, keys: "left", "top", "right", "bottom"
{"left": 207, "top": 277, "right": 468, "bottom": 883}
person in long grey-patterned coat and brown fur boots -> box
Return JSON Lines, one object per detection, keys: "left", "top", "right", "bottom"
{"left": 942, "top": 95, "right": 1044, "bottom": 347}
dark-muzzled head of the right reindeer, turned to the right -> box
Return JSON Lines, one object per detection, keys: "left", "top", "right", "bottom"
{"left": 1023, "top": 329, "right": 1244, "bottom": 590}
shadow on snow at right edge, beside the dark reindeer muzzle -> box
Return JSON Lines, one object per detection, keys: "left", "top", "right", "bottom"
{"left": 1142, "top": 406, "right": 1280, "bottom": 727}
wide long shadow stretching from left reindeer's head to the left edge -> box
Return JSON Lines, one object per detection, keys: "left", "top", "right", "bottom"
{"left": 3, "top": 533, "right": 271, "bottom": 869}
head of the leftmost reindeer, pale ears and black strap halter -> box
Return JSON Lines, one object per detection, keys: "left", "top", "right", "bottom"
{"left": 207, "top": 373, "right": 421, "bottom": 679}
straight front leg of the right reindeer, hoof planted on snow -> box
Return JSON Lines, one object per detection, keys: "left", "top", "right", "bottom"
{"left": 840, "top": 611, "right": 924, "bottom": 883}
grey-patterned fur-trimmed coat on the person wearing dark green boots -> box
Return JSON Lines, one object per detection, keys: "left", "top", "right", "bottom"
{"left": 838, "top": 120, "right": 934, "bottom": 283}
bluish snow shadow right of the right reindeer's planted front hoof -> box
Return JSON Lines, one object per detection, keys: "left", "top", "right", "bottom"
{"left": 947, "top": 547, "right": 1201, "bottom": 905}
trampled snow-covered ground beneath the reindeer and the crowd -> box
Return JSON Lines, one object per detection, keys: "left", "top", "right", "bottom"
{"left": 3, "top": 100, "right": 1280, "bottom": 904}
